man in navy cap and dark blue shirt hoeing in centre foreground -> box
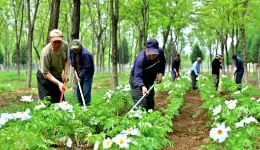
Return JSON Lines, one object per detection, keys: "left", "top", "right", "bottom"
{"left": 130, "top": 39, "right": 166, "bottom": 111}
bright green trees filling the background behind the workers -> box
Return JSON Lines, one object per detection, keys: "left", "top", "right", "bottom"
{"left": 0, "top": 0, "right": 260, "bottom": 87}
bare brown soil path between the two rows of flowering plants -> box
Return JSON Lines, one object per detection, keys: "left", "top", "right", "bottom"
{"left": 156, "top": 90, "right": 209, "bottom": 150}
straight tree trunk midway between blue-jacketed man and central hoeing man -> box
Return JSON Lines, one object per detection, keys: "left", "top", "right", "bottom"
{"left": 110, "top": 0, "right": 119, "bottom": 88}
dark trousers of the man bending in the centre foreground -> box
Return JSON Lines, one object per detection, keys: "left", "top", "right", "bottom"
{"left": 130, "top": 75, "right": 155, "bottom": 111}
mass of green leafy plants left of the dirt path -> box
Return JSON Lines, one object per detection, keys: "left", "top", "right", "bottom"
{"left": 0, "top": 70, "right": 189, "bottom": 150}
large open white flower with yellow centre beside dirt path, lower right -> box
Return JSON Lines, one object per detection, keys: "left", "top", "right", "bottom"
{"left": 209, "top": 123, "right": 231, "bottom": 143}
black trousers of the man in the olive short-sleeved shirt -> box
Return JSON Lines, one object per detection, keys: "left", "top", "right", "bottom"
{"left": 37, "top": 70, "right": 65, "bottom": 103}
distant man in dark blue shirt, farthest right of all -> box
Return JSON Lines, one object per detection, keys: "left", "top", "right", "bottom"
{"left": 232, "top": 55, "right": 244, "bottom": 90}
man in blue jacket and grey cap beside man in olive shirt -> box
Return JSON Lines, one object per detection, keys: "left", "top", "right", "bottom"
{"left": 70, "top": 39, "right": 94, "bottom": 106}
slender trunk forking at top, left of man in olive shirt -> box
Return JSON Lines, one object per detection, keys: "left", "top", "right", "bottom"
{"left": 26, "top": 0, "right": 39, "bottom": 88}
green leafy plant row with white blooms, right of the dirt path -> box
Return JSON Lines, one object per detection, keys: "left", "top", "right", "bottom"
{"left": 199, "top": 74, "right": 260, "bottom": 150}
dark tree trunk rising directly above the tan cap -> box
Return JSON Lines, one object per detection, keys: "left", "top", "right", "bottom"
{"left": 46, "top": 0, "right": 60, "bottom": 43}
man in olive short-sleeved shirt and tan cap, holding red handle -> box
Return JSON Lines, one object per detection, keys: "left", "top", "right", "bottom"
{"left": 37, "top": 29, "right": 69, "bottom": 103}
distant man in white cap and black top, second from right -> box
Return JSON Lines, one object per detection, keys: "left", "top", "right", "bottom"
{"left": 211, "top": 54, "right": 222, "bottom": 91}
